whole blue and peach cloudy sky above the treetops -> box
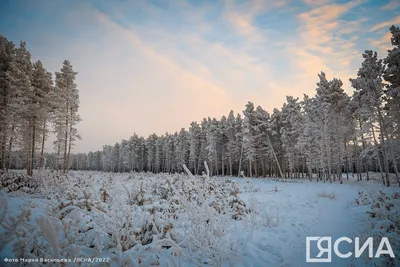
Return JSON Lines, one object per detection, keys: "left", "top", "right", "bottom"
{"left": 0, "top": 0, "right": 400, "bottom": 152}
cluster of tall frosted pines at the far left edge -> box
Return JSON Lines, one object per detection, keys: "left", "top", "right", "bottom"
{"left": 0, "top": 35, "right": 80, "bottom": 176}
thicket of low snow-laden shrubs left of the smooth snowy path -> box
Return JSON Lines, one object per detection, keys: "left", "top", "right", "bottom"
{"left": 0, "top": 171, "right": 254, "bottom": 266}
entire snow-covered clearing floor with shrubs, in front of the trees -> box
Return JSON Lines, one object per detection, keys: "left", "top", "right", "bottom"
{"left": 0, "top": 172, "right": 400, "bottom": 267}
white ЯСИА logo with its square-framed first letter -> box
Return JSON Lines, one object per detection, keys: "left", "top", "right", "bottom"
{"left": 306, "top": 236, "right": 394, "bottom": 262}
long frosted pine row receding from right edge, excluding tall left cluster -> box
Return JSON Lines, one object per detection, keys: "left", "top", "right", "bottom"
{"left": 3, "top": 26, "right": 400, "bottom": 186}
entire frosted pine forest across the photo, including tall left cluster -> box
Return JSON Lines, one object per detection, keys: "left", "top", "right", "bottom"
{"left": 0, "top": 26, "right": 400, "bottom": 186}
